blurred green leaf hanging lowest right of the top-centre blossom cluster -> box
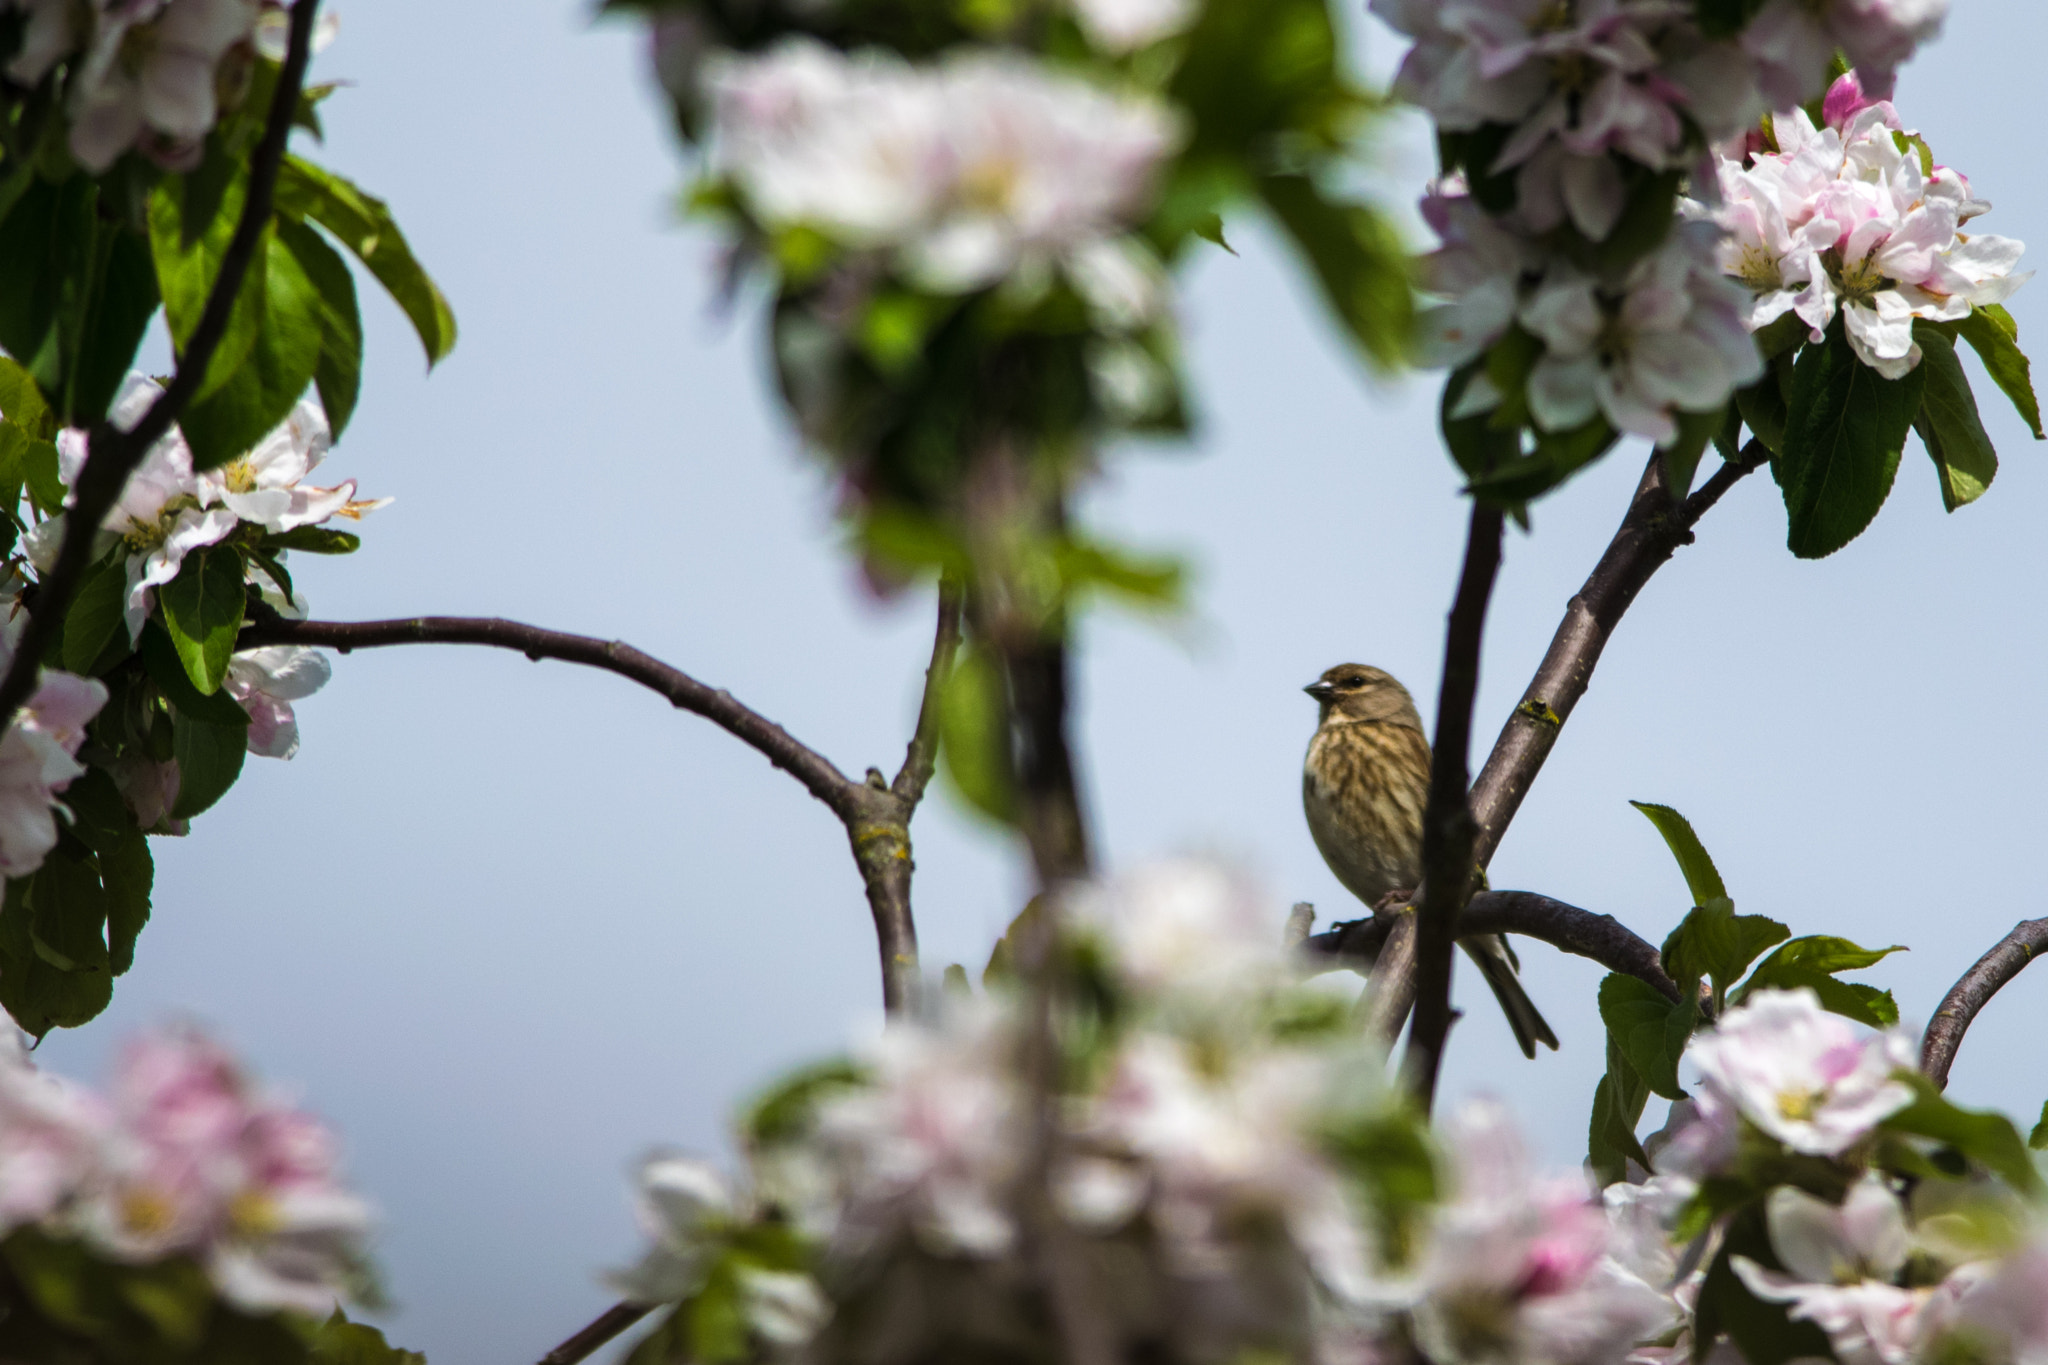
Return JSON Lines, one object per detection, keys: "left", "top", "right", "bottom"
{"left": 1260, "top": 176, "right": 1415, "bottom": 368}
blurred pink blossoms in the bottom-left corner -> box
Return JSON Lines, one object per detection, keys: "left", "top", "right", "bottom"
{"left": 0, "top": 1025, "right": 371, "bottom": 1318}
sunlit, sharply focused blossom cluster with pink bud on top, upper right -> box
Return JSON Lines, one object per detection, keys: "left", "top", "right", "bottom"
{"left": 1688, "top": 72, "right": 2032, "bottom": 379}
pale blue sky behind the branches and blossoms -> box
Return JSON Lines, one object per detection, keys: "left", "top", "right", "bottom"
{"left": 43, "top": 0, "right": 2048, "bottom": 1365}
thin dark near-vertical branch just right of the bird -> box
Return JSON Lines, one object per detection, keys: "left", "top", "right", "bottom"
{"left": 1403, "top": 499, "right": 1501, "bottom": 1113}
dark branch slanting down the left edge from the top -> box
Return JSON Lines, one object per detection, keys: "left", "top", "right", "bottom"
{"left": 0, "top": 0, "right": 319, "bottom": 733}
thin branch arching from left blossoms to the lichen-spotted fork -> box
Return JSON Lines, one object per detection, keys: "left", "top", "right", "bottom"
{"left": 236, "top": 616, "right": 856, "bottom": 821}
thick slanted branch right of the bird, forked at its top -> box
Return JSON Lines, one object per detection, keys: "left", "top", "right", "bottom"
{"left": 1473, "top": 440, "right": 1769, "bottom": 868}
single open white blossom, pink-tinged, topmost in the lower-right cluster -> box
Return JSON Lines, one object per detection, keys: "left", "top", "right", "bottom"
{"left": 1686, "top": 986, "right": 1917, "bottom": 1156}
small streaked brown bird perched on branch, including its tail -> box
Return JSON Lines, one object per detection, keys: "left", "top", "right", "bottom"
{"left": 1300, "top": 663, "right": 1556, "bottom": 1056}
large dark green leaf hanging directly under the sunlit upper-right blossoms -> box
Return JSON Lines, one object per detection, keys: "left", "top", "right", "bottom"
{"left": 1780, "top": 321, "right": 1927, "bottom": 559}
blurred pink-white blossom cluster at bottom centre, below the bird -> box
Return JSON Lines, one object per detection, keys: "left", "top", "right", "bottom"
{"left": 614, "top": 862, "right": 1712, "bottom": 1365}
